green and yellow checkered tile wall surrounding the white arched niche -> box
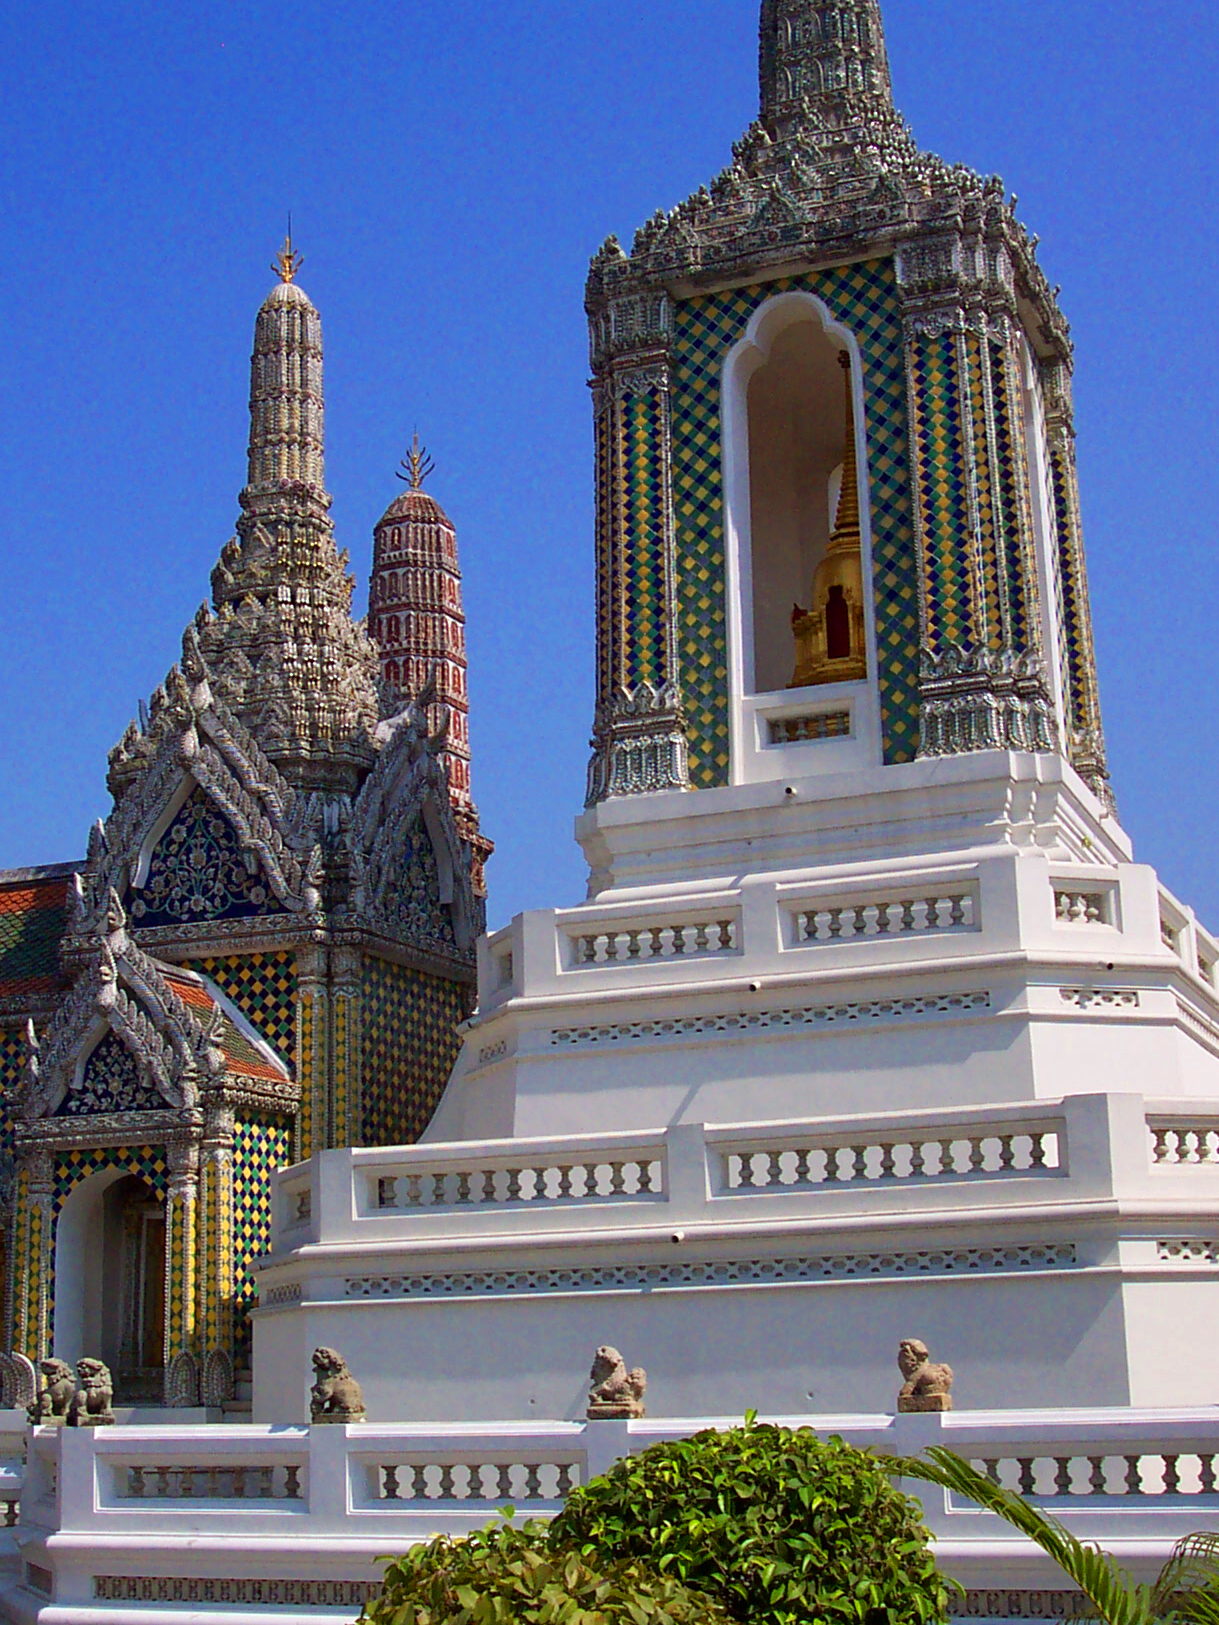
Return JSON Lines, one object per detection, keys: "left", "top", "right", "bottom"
{"left": 673, "top": 260, "right": 920, "bottom": 788}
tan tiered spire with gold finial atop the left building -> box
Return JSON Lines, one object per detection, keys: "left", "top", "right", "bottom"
{"left": 200, "top": 239, "right": 379, "bottom": 790}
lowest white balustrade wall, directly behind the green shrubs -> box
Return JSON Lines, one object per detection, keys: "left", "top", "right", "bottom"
{"left": 0, "top": 1407, "right": 1219, "bottom": 1625}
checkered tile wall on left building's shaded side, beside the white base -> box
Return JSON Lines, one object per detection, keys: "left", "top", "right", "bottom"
{"left": 362, "top": 959, "right": 471, "bottom": 1146}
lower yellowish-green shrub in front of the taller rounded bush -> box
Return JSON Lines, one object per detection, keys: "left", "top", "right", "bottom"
{"left": 361, "top": 1523, "right": 730, "bottom": 1625}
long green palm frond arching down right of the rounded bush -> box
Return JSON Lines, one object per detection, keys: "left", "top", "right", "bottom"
{"left": 889, "top": 1445, "right": 1157, "bottom": 1625}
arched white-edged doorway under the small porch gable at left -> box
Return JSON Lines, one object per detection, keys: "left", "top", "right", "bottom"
{"left": 55, "top": 1172, "right": 166, "bottom": 1406}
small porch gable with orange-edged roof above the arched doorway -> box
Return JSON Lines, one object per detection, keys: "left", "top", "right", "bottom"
{"left": 21, "top": 891, "right": 293, "bottom": 1125}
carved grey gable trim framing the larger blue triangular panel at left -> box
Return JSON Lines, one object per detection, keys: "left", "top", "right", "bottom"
{"left": 83, "top": 626, "right": 322, "bottom": 936}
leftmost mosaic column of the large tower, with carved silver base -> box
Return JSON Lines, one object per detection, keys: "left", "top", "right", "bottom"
{"left": 588, "top": 293, "right": 689, "bottom": 806}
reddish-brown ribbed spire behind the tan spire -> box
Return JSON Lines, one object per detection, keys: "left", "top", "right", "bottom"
{"left": 369, "top": 436, "right": 491, "bottom": 892}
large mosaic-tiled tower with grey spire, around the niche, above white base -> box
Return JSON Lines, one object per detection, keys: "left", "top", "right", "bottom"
{"left": 585, "top": 0, "right": 1110, "bottom": 803}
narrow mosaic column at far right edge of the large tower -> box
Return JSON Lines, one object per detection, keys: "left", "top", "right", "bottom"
{"left": 1042, "top": 362, "right": 1113, "bottom": 806}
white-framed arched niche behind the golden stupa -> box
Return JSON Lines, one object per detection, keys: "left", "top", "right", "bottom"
{"left": 722, "top": 291, "right": 881, "bottom": 783}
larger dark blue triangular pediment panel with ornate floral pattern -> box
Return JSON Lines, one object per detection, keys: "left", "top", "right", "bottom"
{"left": 125, "top": 787, "right": 283, "bottom": 926}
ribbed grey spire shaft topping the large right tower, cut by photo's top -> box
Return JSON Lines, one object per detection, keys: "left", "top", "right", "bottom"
{"left": 761, "top": 0, "right": 892, "bottom": 135}
